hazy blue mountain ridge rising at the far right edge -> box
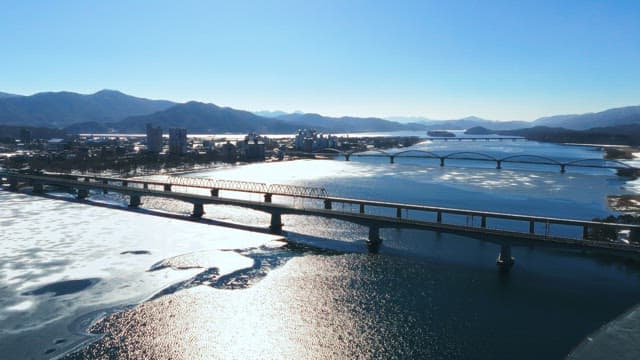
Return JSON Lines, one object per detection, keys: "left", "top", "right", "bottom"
{"left": 533, "top": 106, "right": 640, "bottom": 130}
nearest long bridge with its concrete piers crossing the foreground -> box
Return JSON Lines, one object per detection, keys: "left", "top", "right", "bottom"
{"left": 0, "top": 171, "right": 640, "bottom": 268}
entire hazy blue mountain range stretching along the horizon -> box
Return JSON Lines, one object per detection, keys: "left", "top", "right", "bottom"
{"left": 0, "top": 90, "right": 640, "bottom": 133}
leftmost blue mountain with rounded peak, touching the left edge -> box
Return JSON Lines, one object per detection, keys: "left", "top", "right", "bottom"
{"left": 0, "top": 90, "right": 175, "bottom": 128}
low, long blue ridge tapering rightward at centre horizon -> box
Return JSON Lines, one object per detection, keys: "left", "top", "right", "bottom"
{"left": 278, "top": 114, "right": 425, "bottom": 132}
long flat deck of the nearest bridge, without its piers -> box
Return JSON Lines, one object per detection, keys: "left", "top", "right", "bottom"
{"left": 5, "top": 173, "right": 640, "bottom": 253}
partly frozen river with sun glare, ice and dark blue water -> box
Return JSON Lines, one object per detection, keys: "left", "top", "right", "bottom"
{"left": 0, "top": 136, "right": 640, "bottom": 359}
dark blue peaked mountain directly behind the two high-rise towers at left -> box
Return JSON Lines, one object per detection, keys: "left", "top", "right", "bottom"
{"left": 107, "top": 101, "right": 295, "bottom": 134}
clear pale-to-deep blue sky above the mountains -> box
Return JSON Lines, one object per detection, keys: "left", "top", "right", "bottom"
{"left": 0, "top": 0, "right": 640, "bottom": 120}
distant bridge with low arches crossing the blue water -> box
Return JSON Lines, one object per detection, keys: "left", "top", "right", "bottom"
{"left": 291, "top": 148, "right": 640, "bottom": 176}
